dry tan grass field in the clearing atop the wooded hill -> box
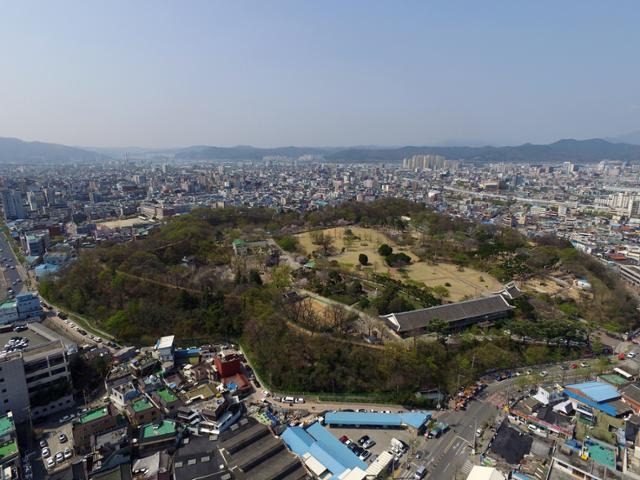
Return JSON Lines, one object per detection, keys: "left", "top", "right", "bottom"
{"left": 297, "top": 227, "right": 501, "bottom": 301}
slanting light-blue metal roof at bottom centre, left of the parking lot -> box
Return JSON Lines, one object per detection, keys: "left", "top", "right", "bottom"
{"left": 282, "top": 422, "right": 367, "bottom": 479}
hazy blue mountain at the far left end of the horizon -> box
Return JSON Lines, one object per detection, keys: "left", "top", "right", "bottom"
{"left": 0, "top": 137, "right": 108, "bottom": 163}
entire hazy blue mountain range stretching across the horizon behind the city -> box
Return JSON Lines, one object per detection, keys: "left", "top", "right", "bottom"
{"left": 0, "top": 133, "right": 640, "bottom": 163}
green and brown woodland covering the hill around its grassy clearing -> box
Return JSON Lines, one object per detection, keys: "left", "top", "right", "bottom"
{"left": 40, "top": 200, "right": 636, "bottom": 401}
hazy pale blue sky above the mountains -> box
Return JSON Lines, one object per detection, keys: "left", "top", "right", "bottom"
{"left": 0, "top": 0, "right": 640, "bottom": 147}
